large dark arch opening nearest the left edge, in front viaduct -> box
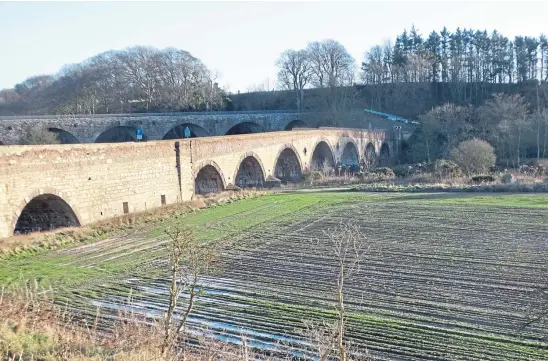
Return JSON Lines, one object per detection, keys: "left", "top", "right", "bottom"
{"left": 14, "top": 194, "right": 80, "bottom": 234}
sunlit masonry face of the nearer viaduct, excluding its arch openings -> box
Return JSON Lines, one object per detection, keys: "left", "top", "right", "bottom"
{"left": 0, "top": 128, "right": 386, "bottom": 238}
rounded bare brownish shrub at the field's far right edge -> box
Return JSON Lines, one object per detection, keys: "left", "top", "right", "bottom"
{"left": 449, "top": 139, "right": 497, "bottom": 174}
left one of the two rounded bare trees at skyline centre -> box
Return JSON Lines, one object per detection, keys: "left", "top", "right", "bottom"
{"left": 276, "top": 49, "right": 312, "bottom": 112}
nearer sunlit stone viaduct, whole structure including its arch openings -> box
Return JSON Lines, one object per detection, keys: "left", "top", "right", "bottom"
{"left": 0, "top": 127, "right": 391, "bottom": 238}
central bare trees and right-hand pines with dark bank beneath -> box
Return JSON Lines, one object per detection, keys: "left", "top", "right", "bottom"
{"left": 239, "top": 26, "right": 548, "bottom": 118}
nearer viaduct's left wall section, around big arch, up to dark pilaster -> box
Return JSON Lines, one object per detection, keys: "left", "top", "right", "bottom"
{"left": 0, "top": 141, "right": 191, "bottom": 237}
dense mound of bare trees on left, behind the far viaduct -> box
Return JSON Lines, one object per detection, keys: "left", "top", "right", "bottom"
{"left": 0, "top": 46, "right": 226, "bottom": 115}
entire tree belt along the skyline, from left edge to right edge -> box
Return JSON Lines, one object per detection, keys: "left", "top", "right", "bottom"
{"left": 4, "top": 26, "right": 548, "bottom": 119}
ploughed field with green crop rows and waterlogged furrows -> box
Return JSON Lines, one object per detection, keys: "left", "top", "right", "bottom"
{"left": 0, "top": 192, "right": 548, "bottom": 360}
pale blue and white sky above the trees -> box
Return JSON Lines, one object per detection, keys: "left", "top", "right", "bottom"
{"left": 0, "top": 1, "right": 548, "bottom": 93}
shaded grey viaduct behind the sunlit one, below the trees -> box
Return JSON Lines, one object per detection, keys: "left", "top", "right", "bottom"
{"left": 0, "top": 111, "right": 378, "bottom": 145}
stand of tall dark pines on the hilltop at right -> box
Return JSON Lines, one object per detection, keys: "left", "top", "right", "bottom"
{"left": 361, "top": 26, "right": 548, "bottom": 111}
